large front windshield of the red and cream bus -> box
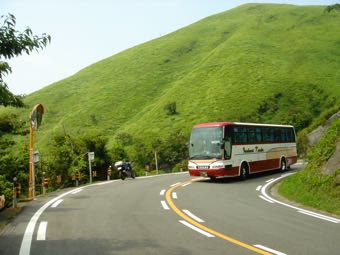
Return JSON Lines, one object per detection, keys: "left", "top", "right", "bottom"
{"left": 189, "top": 127, "right": 223, "bottom": 159}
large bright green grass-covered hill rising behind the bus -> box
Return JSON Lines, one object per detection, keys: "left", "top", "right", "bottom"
{"left": 7, "top": 4, "right": 340, "bottom": 149}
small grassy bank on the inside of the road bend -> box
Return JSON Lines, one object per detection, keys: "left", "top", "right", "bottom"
{"left": 279, "top": 120, "right": 340, "bottom": 215}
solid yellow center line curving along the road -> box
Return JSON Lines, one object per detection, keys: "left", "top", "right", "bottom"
{"left": 165, "top": 181, "right": 272, "bottom": 255}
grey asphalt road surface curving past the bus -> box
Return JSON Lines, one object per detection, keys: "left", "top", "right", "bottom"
{"left": 0, "top": 162, "right": 340, "bottom": 255}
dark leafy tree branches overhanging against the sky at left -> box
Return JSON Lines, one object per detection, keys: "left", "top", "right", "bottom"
{"left": 0, "top": 14, "right": 51, "bottom": 107}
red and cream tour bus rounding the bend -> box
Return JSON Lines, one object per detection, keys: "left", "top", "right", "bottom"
{"left": 188, "top": 122, "right": 297, "bottom": 179}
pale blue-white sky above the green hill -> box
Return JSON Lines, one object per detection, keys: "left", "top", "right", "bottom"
{"left": 0, "top": 0, "right": 340, "bottom": 95}
